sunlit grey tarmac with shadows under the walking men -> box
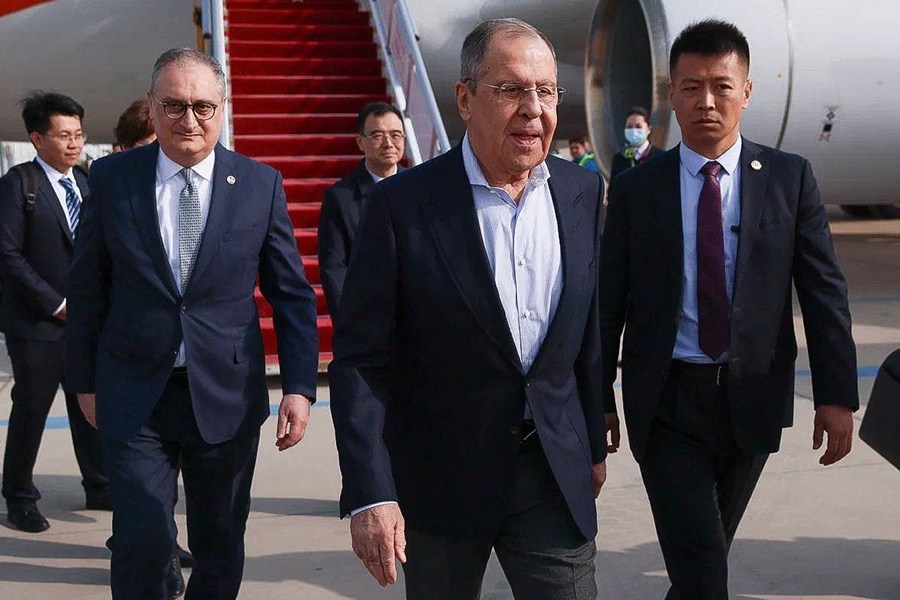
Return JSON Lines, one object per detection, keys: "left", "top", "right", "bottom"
{"left": 0, "top": 212, "right": 900, "bottom": 600}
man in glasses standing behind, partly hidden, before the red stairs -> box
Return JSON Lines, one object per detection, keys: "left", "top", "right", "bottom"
{"left": 318, "top": 102, "right": 406, "bottom": 317}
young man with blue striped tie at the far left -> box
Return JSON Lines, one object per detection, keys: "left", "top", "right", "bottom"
{"left": 0, "top": 92, "right": 109, "bottom": 533}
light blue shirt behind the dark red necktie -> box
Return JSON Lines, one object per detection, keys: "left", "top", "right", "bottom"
{"left": 672, "top": 136, "right": 741, "bottom": 363}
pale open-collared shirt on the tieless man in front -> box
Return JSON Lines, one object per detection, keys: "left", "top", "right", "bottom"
{"left": 462, "top": 134, "right": 563, "bottom": 372}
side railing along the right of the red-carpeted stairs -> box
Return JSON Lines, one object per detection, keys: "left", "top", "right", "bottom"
{"left": 366, "top": 0, "right": 450, "bottom": 164}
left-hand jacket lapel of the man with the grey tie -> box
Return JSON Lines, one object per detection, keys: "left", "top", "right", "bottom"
{"left": 125, "top": 143, "right": 180, "bottom": 297}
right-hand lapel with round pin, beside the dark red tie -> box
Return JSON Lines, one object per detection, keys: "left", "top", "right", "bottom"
{"left": 732, "top": 139, "right": 769, "bottom": 297}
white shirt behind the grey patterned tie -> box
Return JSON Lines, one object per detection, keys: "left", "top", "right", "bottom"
{"left": 156, "top": 148, "right": 216, "bottom": 367}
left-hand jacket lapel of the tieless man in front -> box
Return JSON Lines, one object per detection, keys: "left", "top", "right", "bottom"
{"left": 422, "top": 146, "right": 522, "bottom": 371}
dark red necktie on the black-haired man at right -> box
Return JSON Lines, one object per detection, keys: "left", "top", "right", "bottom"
{"left": 697, "top": 161, "right": 730, "bottom": 360}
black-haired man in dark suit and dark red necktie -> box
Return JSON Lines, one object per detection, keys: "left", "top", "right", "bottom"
{"left": 600, "top": 21, "right": 859, "bottom": 600}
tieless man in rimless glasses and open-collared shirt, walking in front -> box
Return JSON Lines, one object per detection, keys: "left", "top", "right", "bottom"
{"left": 329, "top": 19, "right": 607, "bottom": 600}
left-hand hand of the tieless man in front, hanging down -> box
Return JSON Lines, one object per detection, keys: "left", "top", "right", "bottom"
{"left": 350, "top": 503, "right": 406, "bottom": 587}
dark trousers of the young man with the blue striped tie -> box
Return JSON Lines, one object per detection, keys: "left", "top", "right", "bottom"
{"left": 3, "top": 337, "right": 108, "bottom": 508}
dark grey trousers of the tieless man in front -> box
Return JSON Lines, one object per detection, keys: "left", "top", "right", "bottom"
{"left": 403, "top": 445, "right": 597, "bottom": 600}
